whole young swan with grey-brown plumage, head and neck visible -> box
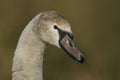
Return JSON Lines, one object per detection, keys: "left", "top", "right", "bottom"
{"left": 12, "top": 11, "right": 85, "bottom": 80}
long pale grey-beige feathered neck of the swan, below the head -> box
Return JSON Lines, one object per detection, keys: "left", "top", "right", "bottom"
{"left": 12, "top": 22, "right": 45, "bottom": 80}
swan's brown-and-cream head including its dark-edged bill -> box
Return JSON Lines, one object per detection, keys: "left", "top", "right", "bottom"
{"left": 36, "top": 11, "right": 85, "bottom": 63}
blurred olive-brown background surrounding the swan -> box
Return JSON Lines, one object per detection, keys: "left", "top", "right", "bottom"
{"left": 0, "top": 0, "right": 120, "bottom": 80}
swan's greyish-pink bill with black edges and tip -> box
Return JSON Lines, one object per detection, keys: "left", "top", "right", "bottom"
{"left": 59, "top": 35, "right": 85, "bottom": 63}
